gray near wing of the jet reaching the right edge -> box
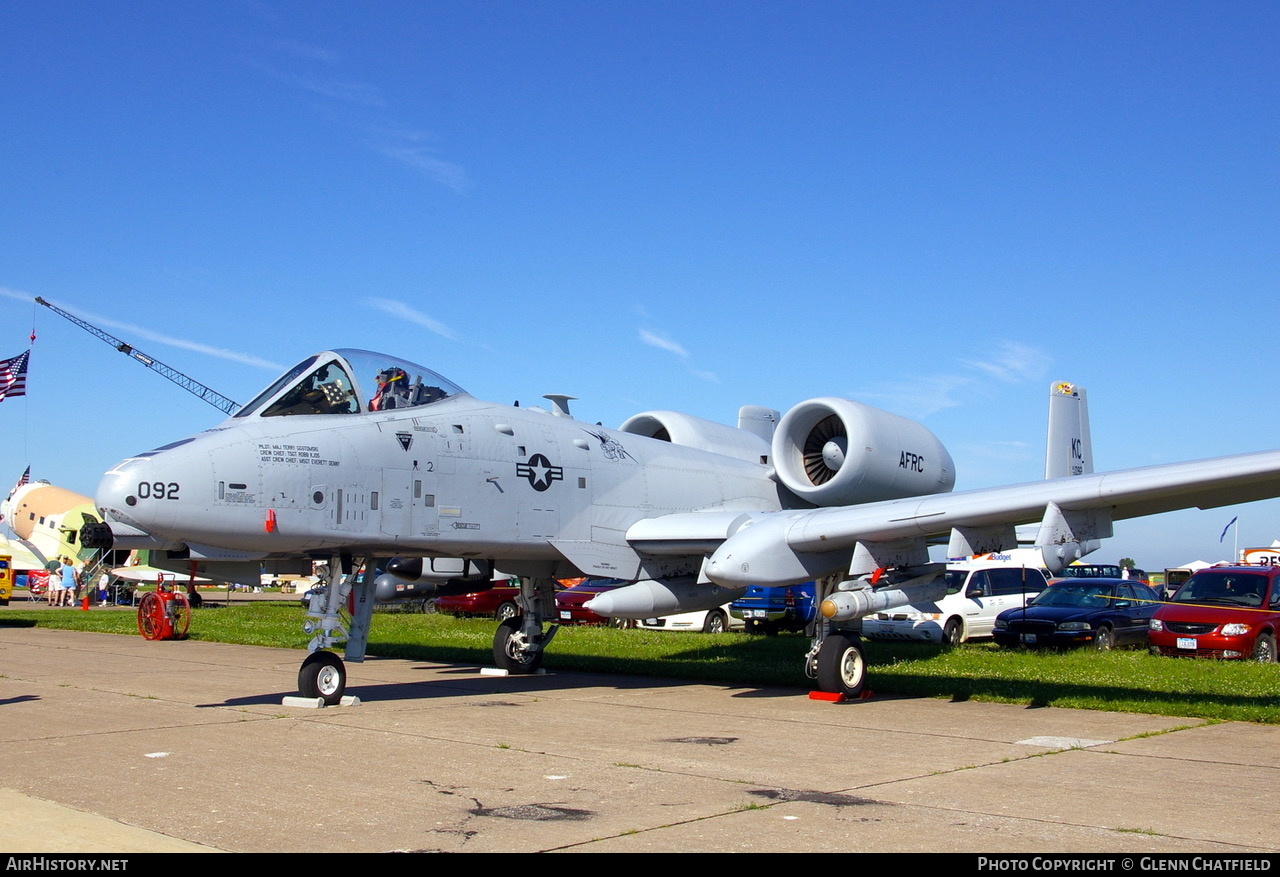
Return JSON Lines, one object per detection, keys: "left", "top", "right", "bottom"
{"left": 705, "top": 451, "right": 1280, "bottom": 586}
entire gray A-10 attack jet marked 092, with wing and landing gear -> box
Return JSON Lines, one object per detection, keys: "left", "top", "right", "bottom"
{"left": 84, "top": 350, "right": 1280, "bottom": 703}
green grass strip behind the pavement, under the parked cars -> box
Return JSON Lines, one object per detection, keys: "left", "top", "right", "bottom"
{"left": 0, "top": 600, "right": 1280, "bottom": 723}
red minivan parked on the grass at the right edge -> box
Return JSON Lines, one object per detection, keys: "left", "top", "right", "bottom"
{"left": 1147, "top": 565, "right": 1280, "bottom": 662}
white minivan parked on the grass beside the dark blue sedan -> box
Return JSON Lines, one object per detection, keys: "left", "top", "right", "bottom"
{"left": 861, "top": 549, "right": 1048, "bottom": 645}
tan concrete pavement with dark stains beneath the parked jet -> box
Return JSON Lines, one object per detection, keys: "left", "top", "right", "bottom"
{"left": 0, "top": 609, "right": 1280, "bottom": 855}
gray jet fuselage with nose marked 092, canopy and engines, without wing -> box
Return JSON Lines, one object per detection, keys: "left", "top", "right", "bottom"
{"left": 97, "top": 350, "right": 954, "bottom": 588}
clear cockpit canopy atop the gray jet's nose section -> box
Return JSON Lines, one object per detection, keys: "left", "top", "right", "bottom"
{"left": 236, "top": 348, "right": 465, "bottom": 417}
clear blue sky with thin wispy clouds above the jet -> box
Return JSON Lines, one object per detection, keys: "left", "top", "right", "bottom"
{"left": 0, "top": 0, "right": 1280, "bottom": 568}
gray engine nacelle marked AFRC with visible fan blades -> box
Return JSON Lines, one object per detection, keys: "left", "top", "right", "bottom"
{"left": 773, "top": 397, "right": 956, "bottom": 506}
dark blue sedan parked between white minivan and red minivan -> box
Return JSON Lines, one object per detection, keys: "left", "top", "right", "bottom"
{"left": 992, "top": 579, "right": 1164, "bottom": 652}
